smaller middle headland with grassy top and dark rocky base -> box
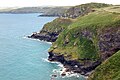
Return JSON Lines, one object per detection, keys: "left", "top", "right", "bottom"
{"left": 28, "top": 18, "right": 73, "bottom": 42}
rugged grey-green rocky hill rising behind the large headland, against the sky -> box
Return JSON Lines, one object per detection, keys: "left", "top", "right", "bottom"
{"left": 63, "top": 3, "right": 112, "bottom": 18}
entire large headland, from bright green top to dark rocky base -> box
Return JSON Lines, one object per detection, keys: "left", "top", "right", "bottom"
{"left": 49, "top": 10, "right": 120, "bottom": 75}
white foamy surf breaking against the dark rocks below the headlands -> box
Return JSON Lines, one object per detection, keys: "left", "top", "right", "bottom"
{"left": 23, "top": 36, "right": 88, "bottom": 80}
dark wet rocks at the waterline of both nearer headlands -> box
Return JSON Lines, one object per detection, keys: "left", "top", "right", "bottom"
{"left": 28, "top": 33, "right": 101, "bottom": 76}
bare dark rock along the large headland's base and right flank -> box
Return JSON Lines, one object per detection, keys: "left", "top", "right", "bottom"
{"left": 49, "top": 27, "right": 120, "bottom": 75}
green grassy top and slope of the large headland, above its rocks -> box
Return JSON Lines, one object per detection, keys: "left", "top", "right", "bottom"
{"left": 49, "top": 7, "right": 120, "bottom": 60}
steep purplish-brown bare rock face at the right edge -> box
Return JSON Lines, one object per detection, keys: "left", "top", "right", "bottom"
{"left": 98, "top": 27, "right": 120, "bottom": 60}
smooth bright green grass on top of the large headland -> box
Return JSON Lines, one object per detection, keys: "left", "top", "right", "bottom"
{"left": 69, "top": 11, "right": 120, "bottom": 29}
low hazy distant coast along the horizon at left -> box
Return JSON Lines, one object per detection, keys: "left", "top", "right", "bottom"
{"left": 0, "top": 6, "right": 69, "bottom": 16}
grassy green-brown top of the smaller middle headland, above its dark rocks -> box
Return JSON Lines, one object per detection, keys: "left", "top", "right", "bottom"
{"left": 39, "top": 18, "right": 73, "bottom": 33}
